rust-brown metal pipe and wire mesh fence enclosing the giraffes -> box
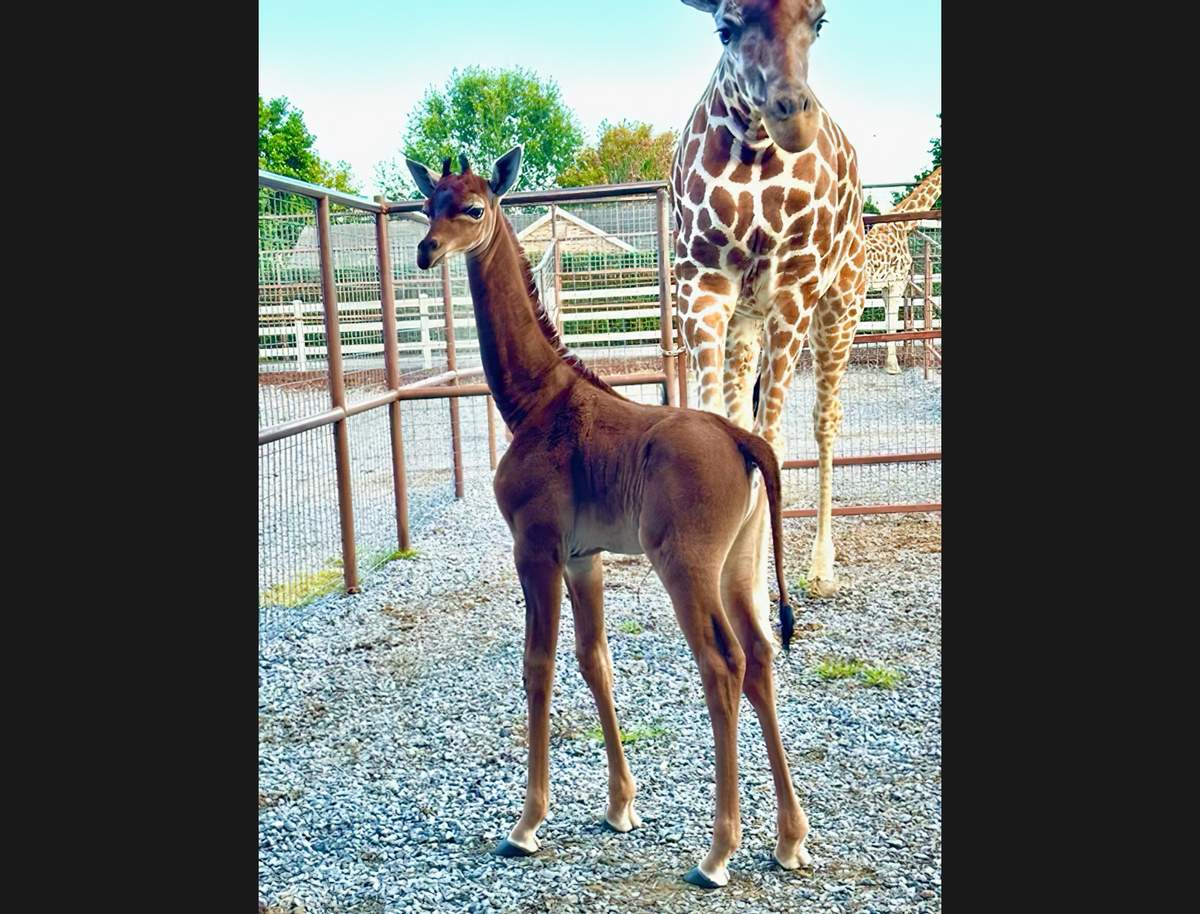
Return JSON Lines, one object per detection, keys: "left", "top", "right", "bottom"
{"left": 258, "top": 172, "right": 941, "bottom": 627}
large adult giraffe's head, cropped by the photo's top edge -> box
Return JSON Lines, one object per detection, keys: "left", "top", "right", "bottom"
{"left": 683, "top": 0, "right": 824, "bottom": 152}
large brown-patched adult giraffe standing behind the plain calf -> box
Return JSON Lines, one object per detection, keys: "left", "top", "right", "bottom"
{"left": 672, "top": 0, "right": 866, "bottom": 597}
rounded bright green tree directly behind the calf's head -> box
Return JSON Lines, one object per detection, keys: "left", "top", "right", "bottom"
{"left": 376, "top": 67, "right": 583, "bottom": 199}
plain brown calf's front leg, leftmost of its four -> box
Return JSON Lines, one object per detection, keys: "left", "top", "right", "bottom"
{"left": 496, "top": 527, "right": 563, "bottom": 856}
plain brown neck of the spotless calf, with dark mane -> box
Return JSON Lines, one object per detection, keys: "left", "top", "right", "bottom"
{"left": 467, "top": 212, "right": 577, "bottom": 431}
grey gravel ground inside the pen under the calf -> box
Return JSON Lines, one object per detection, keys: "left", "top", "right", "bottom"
{"left": 259, "top": 474, "right": 941, "bottom": 914}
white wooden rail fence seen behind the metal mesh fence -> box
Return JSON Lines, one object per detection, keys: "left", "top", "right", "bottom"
{"left": 258, "top": 273, "right": 942, "bottom": 372}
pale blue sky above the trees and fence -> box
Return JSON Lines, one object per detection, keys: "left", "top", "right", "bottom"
{"left": 258, "top": 0, "right": 942, "bottom": 205}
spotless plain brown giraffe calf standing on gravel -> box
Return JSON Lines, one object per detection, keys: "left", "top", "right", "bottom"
{"left": 408, "top": 146, "right": 809, "bottom": 889}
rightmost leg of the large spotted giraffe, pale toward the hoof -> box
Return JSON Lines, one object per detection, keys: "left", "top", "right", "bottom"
{"left": 809, "top": 283, "right": 863, "bottom": 596}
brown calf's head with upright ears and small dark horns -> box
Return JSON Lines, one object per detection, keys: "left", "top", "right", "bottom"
{"left": 406, "top": 145, "right": 524, "bottom": 270}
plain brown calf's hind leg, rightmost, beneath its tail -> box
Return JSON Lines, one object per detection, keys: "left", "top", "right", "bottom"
{"left": 721, "top": 491, "right": 810, "bottom": 870}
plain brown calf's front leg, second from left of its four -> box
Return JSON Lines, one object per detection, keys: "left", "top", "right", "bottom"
{"left": 566, "top": 554, "right": 642, "bottom": 831}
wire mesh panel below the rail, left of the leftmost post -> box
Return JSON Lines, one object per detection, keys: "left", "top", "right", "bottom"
{"left": 258, "top": 426, "right": 342, "bottom": 635}
